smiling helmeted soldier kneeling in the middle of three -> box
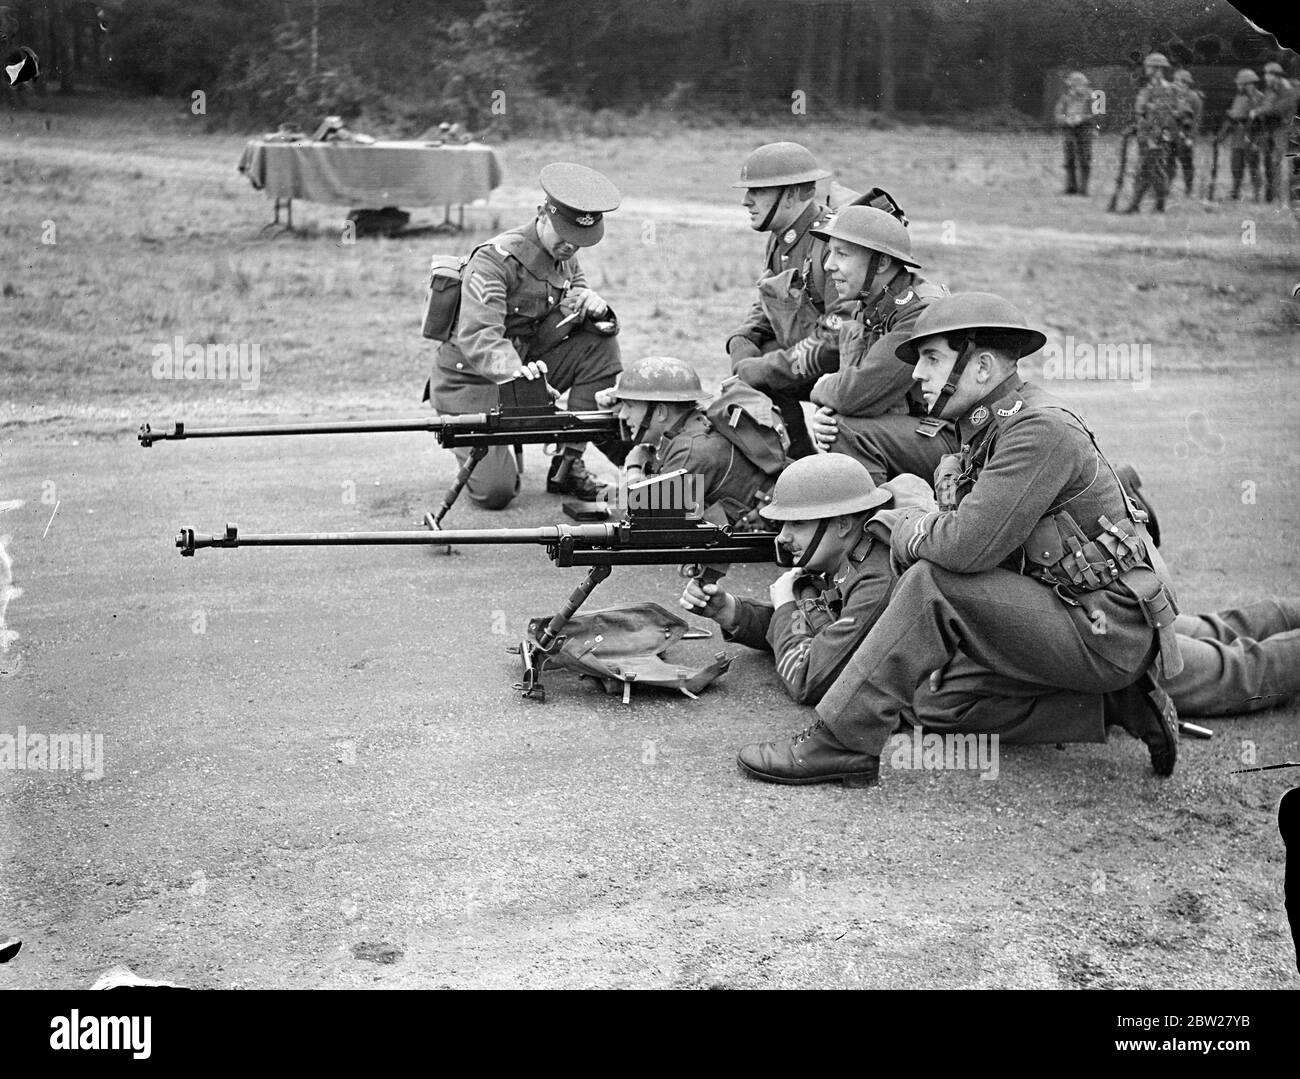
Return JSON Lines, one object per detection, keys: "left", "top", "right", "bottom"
{"left": 811, "top": 205, "right": 957, "bottom": 484}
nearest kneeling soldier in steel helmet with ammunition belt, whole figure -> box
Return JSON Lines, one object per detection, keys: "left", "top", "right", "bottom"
{"left": 740, "top": 293, "right": 1182, "bottom": 785}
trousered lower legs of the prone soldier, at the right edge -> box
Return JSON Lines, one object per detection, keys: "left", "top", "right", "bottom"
{"left": 1162, "top": 599, "right": 1300, "bottom": 716}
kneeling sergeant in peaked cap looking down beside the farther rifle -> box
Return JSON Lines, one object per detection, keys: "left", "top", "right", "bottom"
{"left": 425, "top": 163, "right": 625, "bottom": 510}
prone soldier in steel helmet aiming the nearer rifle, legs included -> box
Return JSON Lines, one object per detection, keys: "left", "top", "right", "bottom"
{"left": 696, "top": 454, "right": 1300, "bottom": 744}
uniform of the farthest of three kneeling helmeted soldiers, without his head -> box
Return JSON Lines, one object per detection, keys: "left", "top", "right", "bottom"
{"left": 727, "top": 203, "right": 845, "bottom": 456}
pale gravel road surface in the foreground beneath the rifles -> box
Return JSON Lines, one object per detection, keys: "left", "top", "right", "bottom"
{"left": 0, "top": 377, "right": 1297, "bottom": 988}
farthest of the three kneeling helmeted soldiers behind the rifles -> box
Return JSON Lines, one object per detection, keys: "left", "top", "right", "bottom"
{"left": 727, "top": 142, "right": 840, "bottom": 459}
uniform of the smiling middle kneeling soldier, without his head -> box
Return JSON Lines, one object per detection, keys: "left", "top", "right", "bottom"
{"left": 813, "top": 269, "right": 957, "bottom": 484}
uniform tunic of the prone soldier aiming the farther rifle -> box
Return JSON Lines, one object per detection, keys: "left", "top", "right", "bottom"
{"left": 628, "top": 410, "right": 772, "bottom": 525}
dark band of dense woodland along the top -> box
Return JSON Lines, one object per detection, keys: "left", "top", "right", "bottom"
{"left": 0, "top": 0, "right": 1294, "bottom": 134}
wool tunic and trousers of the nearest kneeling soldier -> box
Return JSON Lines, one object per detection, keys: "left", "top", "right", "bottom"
{"left": 818, "top": 374, "right": 1178, "bottom": 755}
